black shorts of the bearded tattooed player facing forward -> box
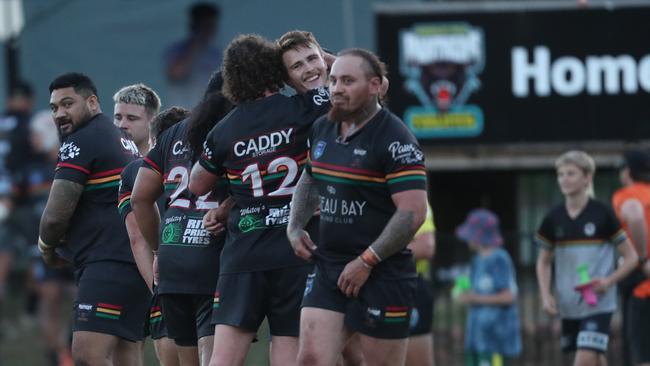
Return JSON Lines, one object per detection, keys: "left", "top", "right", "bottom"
{"left": 302, "top": 262, "right": 417, "bottom": 339}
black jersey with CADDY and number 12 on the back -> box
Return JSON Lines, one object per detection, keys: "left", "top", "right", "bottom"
{"left": 199, "top": 89, "right": 330, "bottom": 273}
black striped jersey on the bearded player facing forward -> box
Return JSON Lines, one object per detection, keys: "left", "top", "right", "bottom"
{"left": 308, "top": 110, "right": 426, "bottom": 278}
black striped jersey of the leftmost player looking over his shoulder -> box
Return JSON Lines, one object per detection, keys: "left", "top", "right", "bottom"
{"left": 54, "top": 113, "right": 138, "bottom": 268}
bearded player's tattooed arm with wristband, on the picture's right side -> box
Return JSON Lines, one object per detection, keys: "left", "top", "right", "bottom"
{"left": 338, "top": 190, "right": 427, "bottom": 297}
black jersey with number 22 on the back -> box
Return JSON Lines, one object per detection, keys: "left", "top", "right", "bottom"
{"left": 143, "top": 120, "right": 227, "bottom": 294}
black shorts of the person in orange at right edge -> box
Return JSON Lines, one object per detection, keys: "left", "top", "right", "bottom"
{"left": 627, "top": 296, "right": 650, "bottom": 365}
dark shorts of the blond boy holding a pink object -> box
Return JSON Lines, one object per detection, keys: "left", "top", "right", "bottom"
{"left": 560, "top": 313, "right": 612, "bottom": 353}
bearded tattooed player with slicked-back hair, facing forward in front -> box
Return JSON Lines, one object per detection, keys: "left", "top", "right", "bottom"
{"left": 287, "top": 49, "right": 427, "bottom": 365}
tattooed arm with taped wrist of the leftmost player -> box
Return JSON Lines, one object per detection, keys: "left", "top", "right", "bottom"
{"left": 38, "top": 179, "right": 84, "bottom": 266}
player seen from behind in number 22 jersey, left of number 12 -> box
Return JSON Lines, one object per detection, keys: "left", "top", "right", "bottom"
{"left": 131, "top": 74, "right": 229, "bottom": 365}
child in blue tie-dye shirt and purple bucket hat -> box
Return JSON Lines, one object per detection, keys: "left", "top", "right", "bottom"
{"left": 456, "top": 208, "right": 521, "bottom": 366}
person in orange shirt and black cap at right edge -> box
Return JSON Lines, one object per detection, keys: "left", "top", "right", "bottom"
{"left": 612, "top": 150, "right": 650, "bottom": 365}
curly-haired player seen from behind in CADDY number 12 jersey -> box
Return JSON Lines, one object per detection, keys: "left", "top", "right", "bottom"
{"left": 190, "top": 35, "right": 329, "bottom": 366}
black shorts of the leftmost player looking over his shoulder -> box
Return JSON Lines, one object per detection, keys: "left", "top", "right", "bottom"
{"left": 73, "top": 262, "right": 151, "bottom": 342}
